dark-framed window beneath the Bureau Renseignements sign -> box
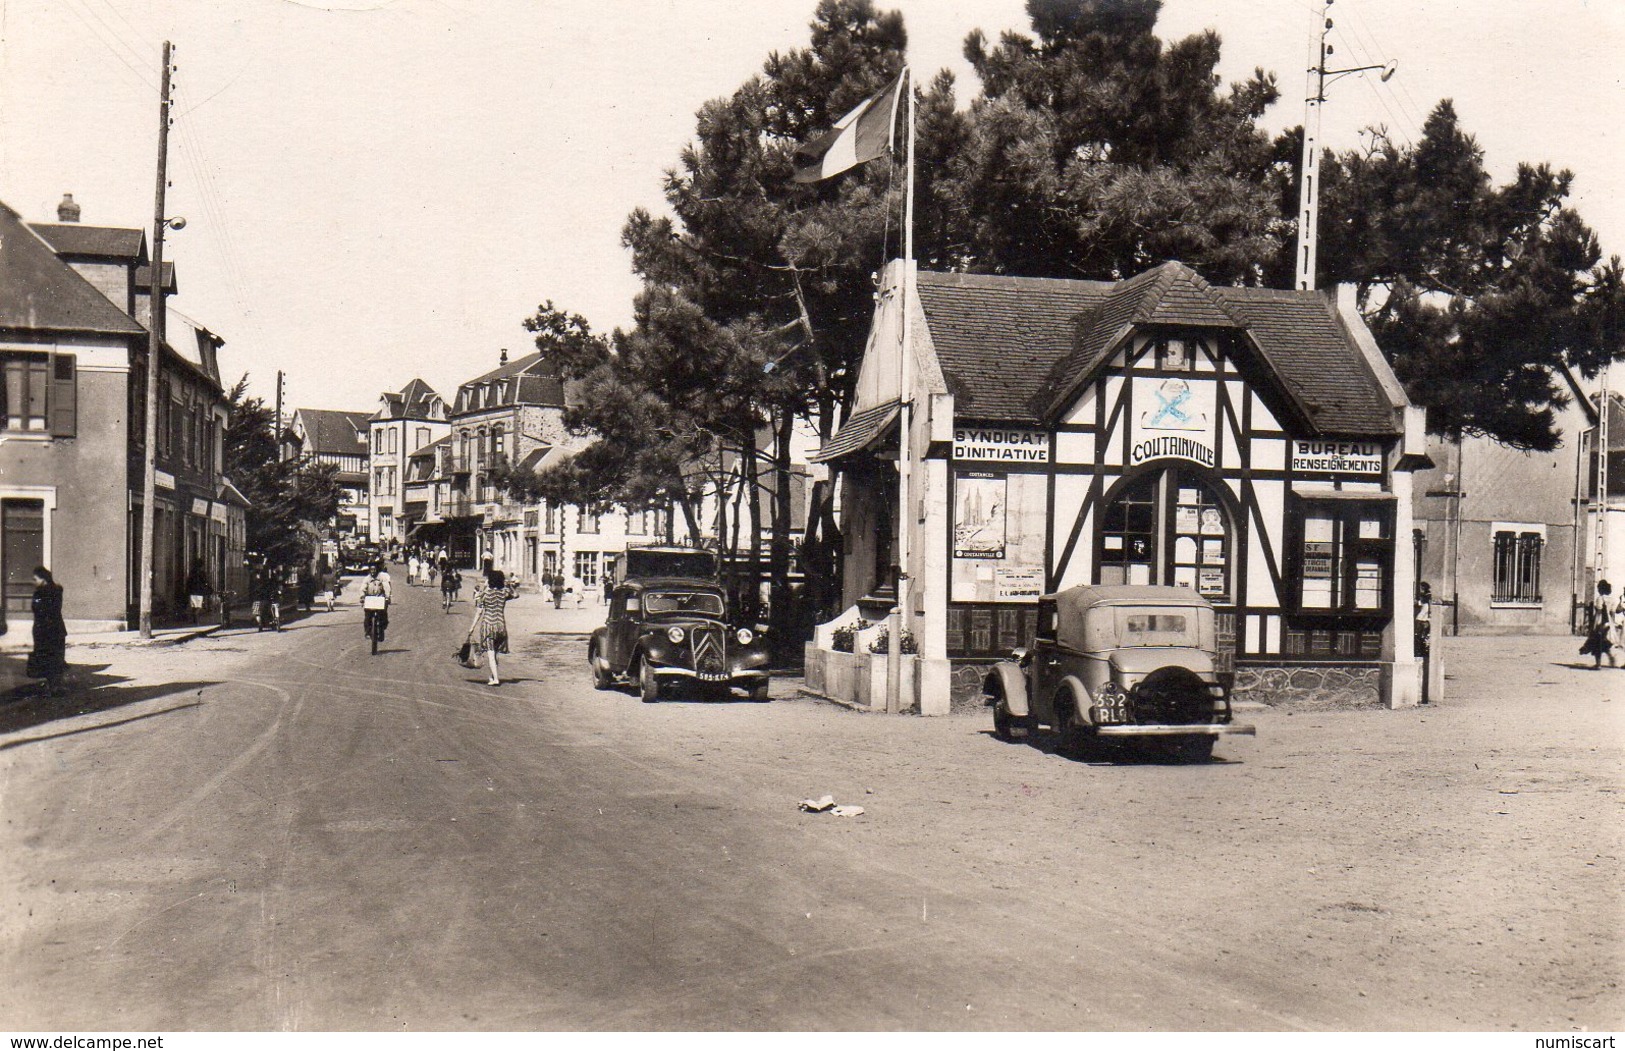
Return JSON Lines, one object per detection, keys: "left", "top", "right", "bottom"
{"left": 1298, "top": 499, "right": 1394, "bottom": 612}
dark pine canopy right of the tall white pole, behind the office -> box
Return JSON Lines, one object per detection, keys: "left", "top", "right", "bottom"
{"left": 1313, "top": 99, "right": 1625, "bottom": 448}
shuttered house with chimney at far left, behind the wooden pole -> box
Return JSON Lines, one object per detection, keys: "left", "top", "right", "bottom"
{"left": 0, "top": 200, "right": 245, "bottom": 630}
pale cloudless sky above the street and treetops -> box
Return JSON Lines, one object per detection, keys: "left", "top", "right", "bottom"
{"left": 0, "top": 0, "right": 1625, "bottom": 411}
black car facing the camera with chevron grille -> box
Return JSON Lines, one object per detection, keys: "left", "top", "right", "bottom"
{"left": 587, "top": 577, "right": 769, "bottom": 702}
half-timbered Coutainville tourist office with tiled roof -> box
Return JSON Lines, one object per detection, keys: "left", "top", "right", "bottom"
{"left": 814, "top": 262, "right": 1428, "bottom": 711}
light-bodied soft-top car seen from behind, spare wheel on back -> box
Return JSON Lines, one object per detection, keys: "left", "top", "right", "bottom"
{"left": 983, "top": 585, "right": 1255, "bottom": 759}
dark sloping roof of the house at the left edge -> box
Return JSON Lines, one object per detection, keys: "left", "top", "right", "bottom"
{"left": 0, "top": 205, "right": 146, "bottom": 336}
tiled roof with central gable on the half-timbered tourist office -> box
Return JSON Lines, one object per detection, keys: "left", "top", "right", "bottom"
{"left": 918, "top": 262, "right": 1398, "bottom": 435}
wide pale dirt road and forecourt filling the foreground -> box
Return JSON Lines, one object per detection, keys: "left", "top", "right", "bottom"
{"left": 0, "top": 593, "right": 1625, "bottom": 1030}
